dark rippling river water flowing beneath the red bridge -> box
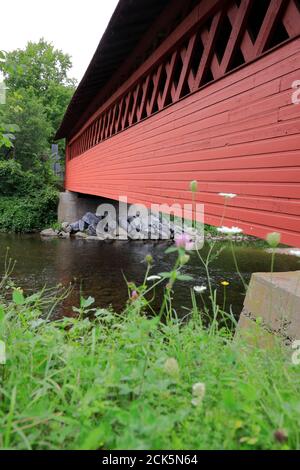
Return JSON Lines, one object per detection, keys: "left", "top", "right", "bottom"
{"left": 0, "top": 234, "right": 300, "bottom": 315}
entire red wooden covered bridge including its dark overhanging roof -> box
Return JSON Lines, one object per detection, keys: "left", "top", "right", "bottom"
{"left": 57, "top": 0, "right": 300, "bottom": 246}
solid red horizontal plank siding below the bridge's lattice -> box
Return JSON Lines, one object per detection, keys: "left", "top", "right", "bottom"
{"left": 66, "top": 40, "right": 300, "bottom": 246}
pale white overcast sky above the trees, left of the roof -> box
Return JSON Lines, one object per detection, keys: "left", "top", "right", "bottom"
{"left": 0, "top": 0, "right": 118, "bottom": 81}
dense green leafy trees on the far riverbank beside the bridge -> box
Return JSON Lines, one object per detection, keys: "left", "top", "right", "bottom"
{"left": 0, "top": 39, "right": 75, "bottom": 232}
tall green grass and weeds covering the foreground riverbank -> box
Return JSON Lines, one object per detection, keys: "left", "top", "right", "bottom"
{"left": 0, "top": 280, "right": 300, "bottom": 449}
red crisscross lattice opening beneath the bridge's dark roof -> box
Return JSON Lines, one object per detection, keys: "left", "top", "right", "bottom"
{"left": 69, "top": 0, "right": 300, "bottom": 158}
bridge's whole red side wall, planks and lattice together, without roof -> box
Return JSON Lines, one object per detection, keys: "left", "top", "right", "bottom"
{"left": 66, "top": 0, "right": 300, "bottom": 246}
